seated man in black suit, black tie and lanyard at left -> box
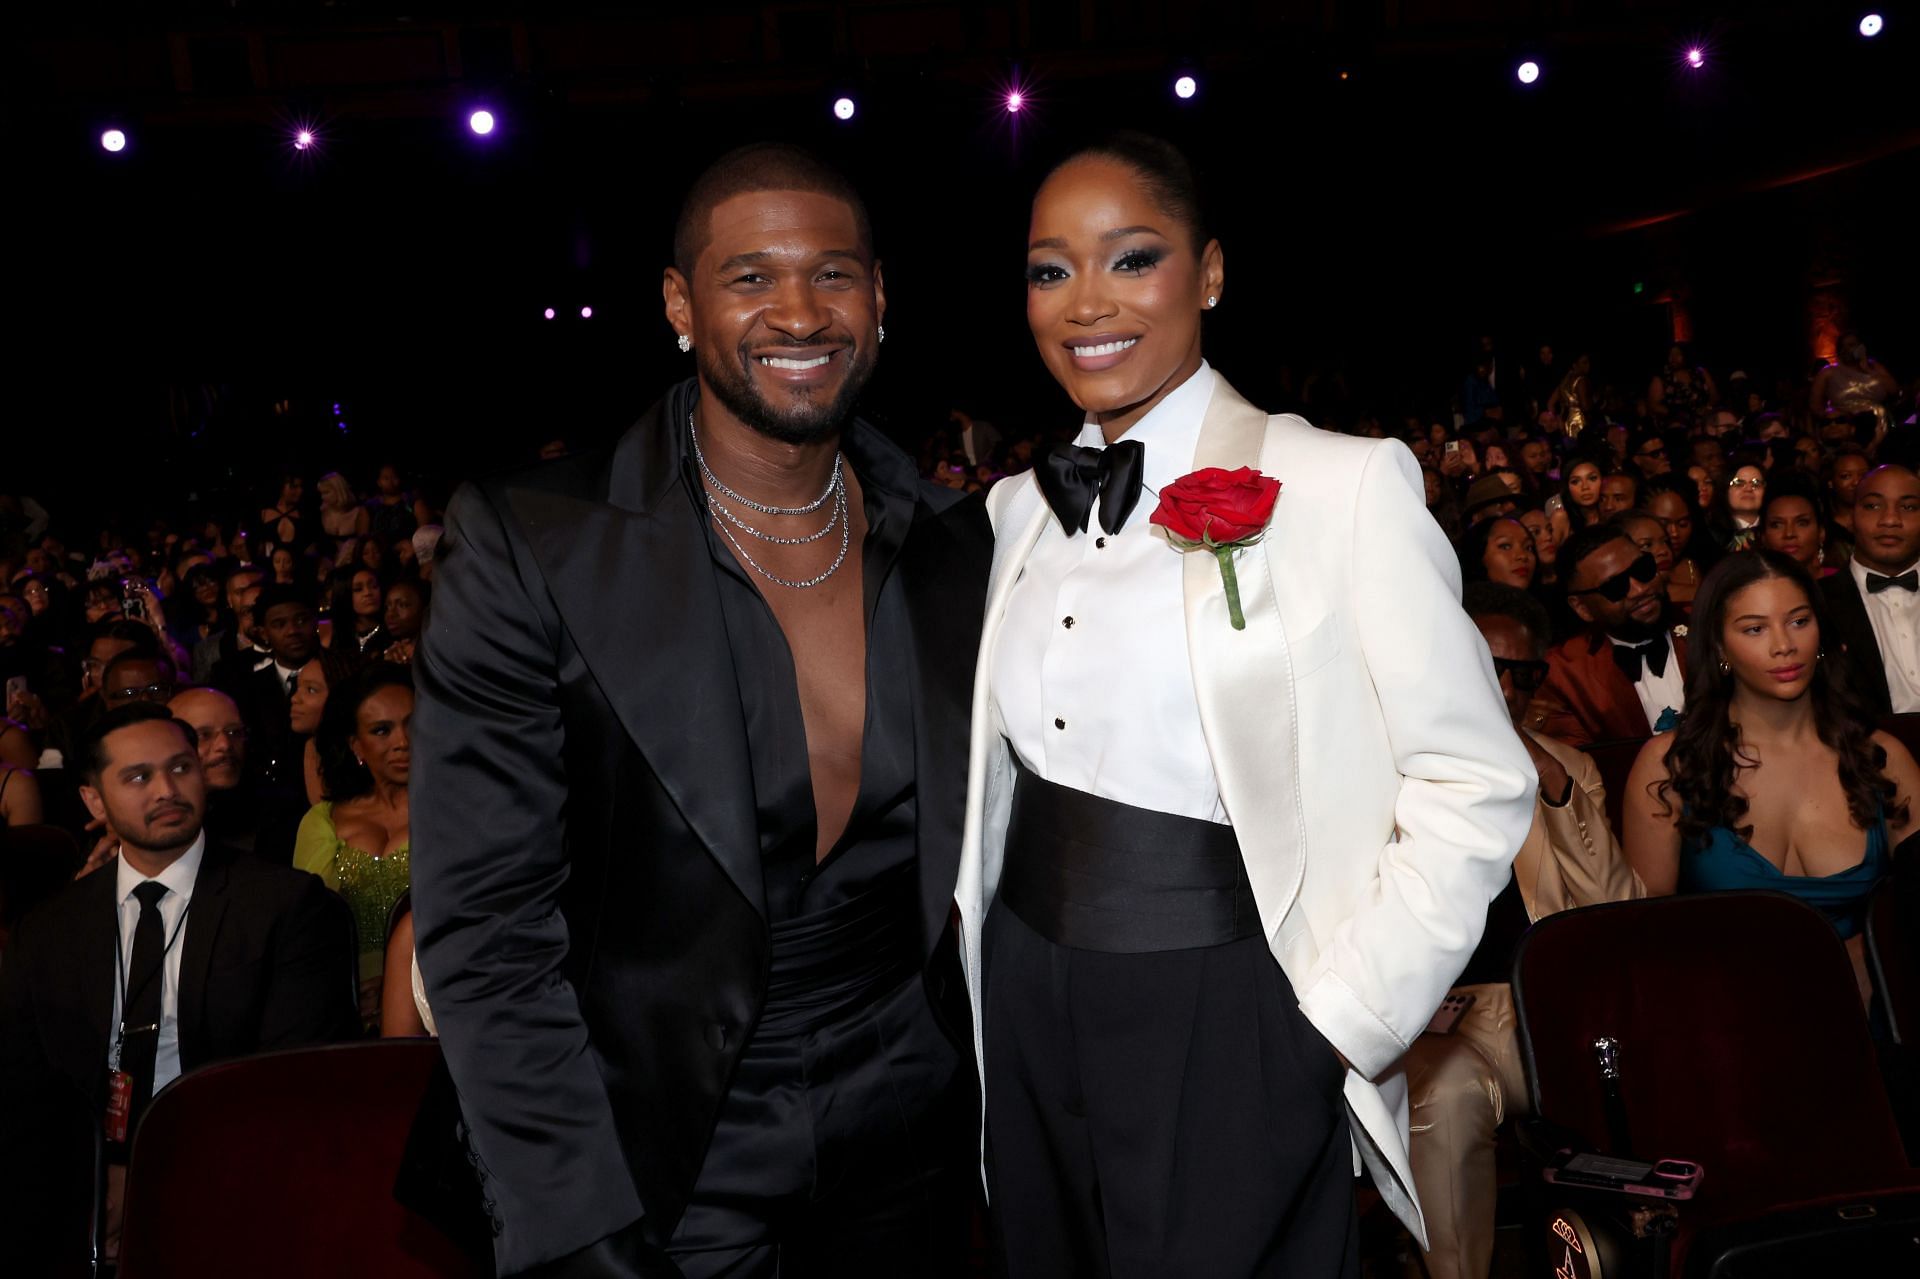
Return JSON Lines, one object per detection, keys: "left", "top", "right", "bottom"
{"left": 0, "top": 703, "right": 359, "bottom": 1273}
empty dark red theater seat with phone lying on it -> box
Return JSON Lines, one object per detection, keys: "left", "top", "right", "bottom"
{"left": 1513, "top": 893, "right": 1920, "bottom": 1275}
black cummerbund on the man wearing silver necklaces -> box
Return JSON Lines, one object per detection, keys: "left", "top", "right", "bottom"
{"left": 755, "top": 862, "right": 920, "bottom": 1035}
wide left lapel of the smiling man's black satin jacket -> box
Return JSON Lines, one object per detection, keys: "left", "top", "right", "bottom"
{"left": 509, "top": 396, "right": 766, "bottom": 912}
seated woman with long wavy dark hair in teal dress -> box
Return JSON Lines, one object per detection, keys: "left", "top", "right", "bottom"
{"left": 1622, "top": 549, "right": 1920, "bottom": 999}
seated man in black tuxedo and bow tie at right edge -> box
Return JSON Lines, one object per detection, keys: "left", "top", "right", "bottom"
{"left": 1820, "top": 465, "right": 1920, "bottom": 714}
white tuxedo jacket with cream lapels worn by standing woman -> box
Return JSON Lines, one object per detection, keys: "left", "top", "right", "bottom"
{"left": 956, "top": 382, "right": 1536, "bottom": 1243}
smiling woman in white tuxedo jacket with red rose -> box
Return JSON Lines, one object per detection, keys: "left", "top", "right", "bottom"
{"left": 956, "top": 134, "right": 1534, "bottom": 1279}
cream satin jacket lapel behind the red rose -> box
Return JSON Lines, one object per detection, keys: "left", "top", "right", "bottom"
{"left": 1183, "top": 380, "right": 1306, "bottom": 949}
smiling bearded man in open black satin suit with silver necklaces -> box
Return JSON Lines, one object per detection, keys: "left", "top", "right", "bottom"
{"left": 413, "top": 146, "right": 991, "bottom": 1279}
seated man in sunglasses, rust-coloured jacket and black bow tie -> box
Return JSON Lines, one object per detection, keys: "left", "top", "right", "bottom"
{"left": 1526, "top": 522, "right": 1686, "bottom": 745}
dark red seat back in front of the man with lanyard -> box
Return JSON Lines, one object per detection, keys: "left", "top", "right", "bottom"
{"left": 119, "top": 1039, "right": 482, "bottom": 1279}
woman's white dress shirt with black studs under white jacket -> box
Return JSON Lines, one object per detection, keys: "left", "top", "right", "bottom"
{"left": 991, "top": 363, "right": 1227, "bottom": 824}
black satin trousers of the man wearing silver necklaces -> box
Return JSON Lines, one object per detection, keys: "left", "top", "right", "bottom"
{"left": 668, "top": 880, "right": 977, "bottom": 1279}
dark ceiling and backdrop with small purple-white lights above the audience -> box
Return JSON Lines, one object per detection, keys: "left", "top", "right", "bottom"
{"left": 8, "top": 0, "right": 1920, "bottom": 503}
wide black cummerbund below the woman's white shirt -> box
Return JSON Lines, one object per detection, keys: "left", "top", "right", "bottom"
{"left": 1000, "top": 760, "right": 1263, "bottom": 954}
